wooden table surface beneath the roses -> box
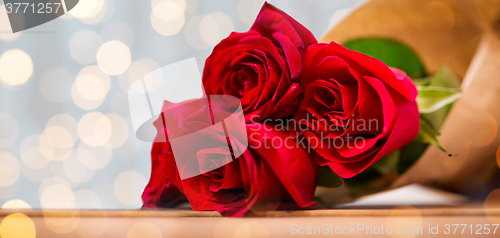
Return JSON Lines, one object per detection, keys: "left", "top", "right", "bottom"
{"left": 0, "top": 205, "right": 500, "bottom": 238}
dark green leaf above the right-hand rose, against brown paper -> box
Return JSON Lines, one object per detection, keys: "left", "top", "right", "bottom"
{"left": 343, "top": 37, "right": 426, "bottom": 78}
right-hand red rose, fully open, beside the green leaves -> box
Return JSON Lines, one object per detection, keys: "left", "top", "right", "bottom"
{"left": 290, "top": 42, "right": 419, "bottom": 178}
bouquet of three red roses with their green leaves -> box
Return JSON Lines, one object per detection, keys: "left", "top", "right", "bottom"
{"left": 142, "top": 3, "right": 459, "bottom": 216}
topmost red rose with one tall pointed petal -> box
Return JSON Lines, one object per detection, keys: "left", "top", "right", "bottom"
{"left": 203, "top": 3, "right": 317, "bottom": 121}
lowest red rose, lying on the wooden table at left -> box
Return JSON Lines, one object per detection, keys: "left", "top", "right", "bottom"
{"left": 145, "top": 102, "right": 318, "bottom": 216}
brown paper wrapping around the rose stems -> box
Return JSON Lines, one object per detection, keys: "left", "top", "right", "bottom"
{"left": 321, "top": 0, "right": 500, "bottom": 194}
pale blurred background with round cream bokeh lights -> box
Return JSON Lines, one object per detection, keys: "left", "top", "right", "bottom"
{"left": 0, "top": 0, "right": 363, "bottom": 209}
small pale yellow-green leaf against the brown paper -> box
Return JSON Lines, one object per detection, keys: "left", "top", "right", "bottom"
{"left": 416, "top": 86, "right": 462, "bottom": 113}
